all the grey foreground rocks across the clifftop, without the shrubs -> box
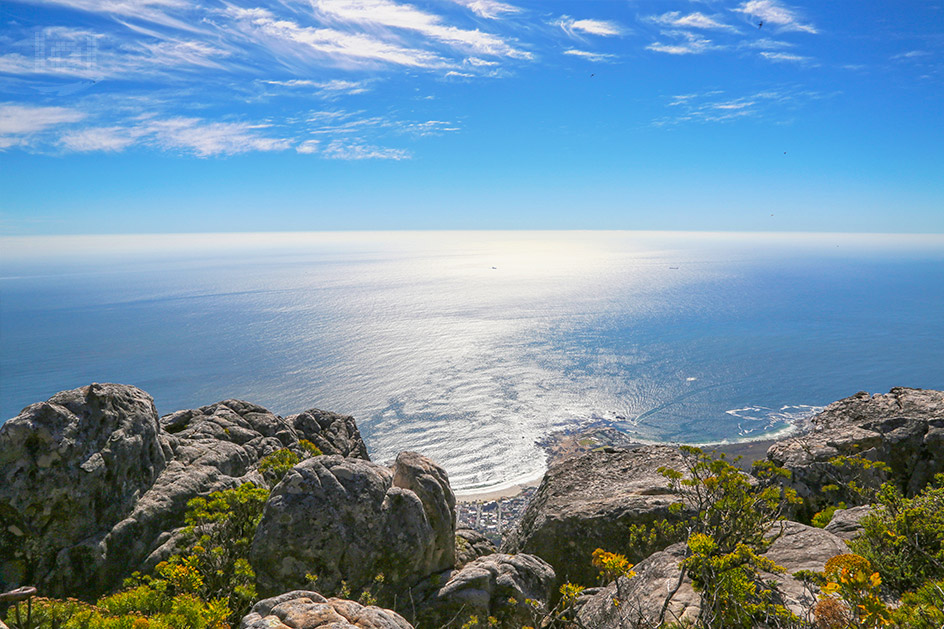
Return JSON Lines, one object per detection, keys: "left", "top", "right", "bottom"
{"left": 0, "top": 384, "right": 944, "bottom": 629}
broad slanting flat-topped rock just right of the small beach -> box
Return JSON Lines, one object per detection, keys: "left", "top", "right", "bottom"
{"left": 502, "top": 446, "right": 684, "bottom": 583}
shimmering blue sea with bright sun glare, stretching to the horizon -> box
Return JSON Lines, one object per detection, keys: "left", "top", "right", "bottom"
{"left": 0, "top": 232, "right": 944, "bottom": 492}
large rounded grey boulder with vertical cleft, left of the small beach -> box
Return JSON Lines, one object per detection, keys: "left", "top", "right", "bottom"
{"left": 250, "top": 453, "right": 455, "bottom": 593}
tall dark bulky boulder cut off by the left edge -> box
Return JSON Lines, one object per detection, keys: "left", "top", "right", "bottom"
{"left": 0, "top": 384, "right": 171, "bottom": 592}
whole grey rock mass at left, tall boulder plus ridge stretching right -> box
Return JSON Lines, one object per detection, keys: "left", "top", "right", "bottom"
{"left": 0, "top": 384, "right": 366, "bottom": 597}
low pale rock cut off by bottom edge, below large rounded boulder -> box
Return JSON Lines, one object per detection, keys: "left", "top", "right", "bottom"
{"left": 239, "top": 590, "right": 413, "bottom": 629}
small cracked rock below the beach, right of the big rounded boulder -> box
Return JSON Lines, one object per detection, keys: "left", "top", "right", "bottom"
{"left": 413, "top": 554, "right": 555, "bottom": 628}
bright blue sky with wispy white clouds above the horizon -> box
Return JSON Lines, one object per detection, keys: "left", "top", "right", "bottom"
{"left": 0, "top": 0, "right": 944, "bottom": 236}
